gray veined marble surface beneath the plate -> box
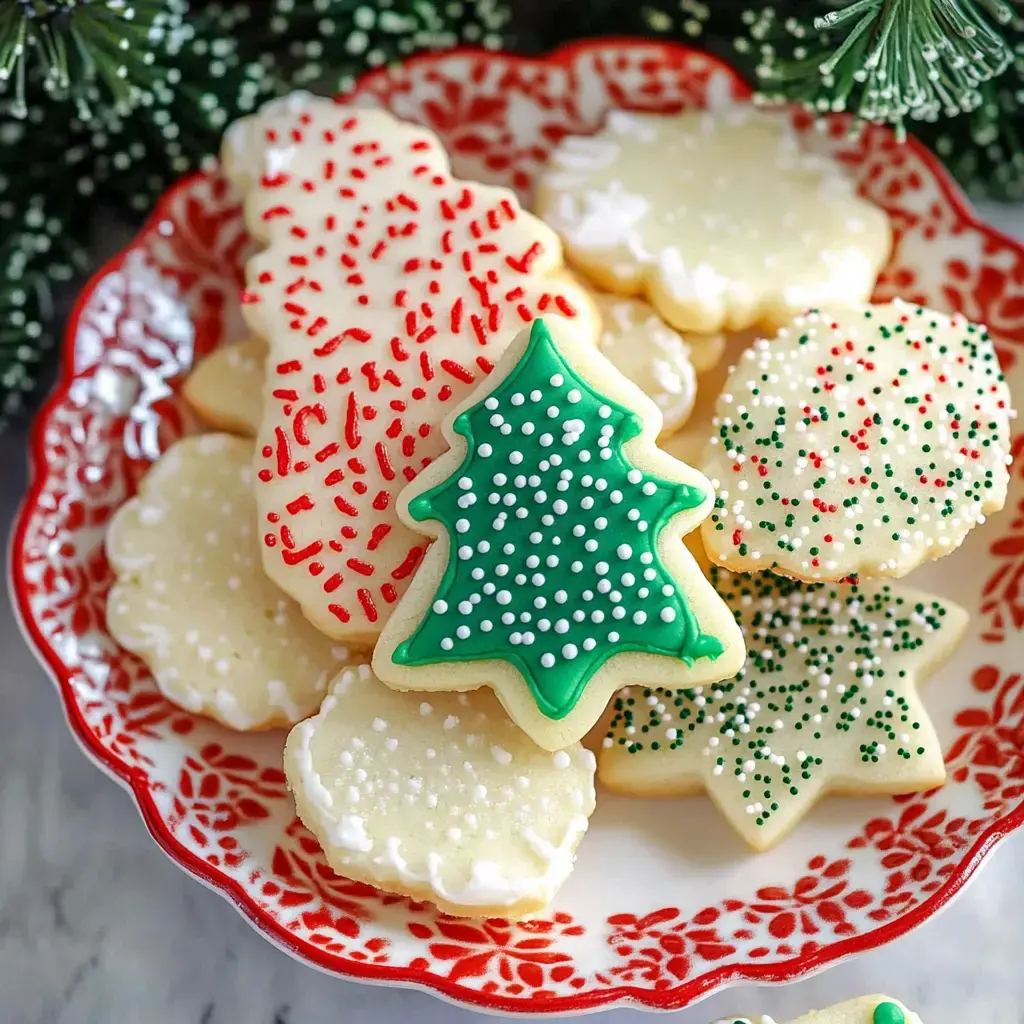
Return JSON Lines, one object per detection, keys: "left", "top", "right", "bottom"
{"left": 6, "top": 201, "right": 1024, "bottom": 1024}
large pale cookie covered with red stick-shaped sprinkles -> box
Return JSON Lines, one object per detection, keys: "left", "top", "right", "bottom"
{"left": 225, "top": 97, "right": 598, "bottom": 641}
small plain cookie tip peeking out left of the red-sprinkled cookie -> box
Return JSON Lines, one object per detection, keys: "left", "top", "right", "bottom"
{"left": 181, "top": 336, "right": 266, "bottom": 437}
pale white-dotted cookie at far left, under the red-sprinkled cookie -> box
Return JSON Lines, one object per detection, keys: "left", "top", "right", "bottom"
{"left": 106, "top": 434, "right": 353, "bottom": 730}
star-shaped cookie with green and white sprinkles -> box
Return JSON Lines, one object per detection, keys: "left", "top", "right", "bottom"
{"left": 599, "top": 565, "right": 968, "bottom": 850}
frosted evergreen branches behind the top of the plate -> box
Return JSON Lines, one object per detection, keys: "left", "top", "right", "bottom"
{"left": 0, "top": 0, "right": 1024, "bottom": 422}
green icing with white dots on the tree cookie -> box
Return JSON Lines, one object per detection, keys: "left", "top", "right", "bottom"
{"left": 393, "top": 319, "right": 723, "bottom": 719}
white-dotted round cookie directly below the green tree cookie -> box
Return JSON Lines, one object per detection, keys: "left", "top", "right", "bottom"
{"left": 285, "top": 666, "right": 594, "bottom": 918}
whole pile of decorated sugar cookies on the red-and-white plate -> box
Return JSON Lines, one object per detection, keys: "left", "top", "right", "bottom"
{"left": 99, "top": 93, "right": 1010, "bottom": 918}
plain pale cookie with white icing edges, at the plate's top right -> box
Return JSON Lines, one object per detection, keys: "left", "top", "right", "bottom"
{"left": 537, "top": 104, "right": 891, "bottom": 333}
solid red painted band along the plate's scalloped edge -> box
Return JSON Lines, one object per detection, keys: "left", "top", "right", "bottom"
{"left": 7, "top": 36, "right": 1024, "bottom": 1016}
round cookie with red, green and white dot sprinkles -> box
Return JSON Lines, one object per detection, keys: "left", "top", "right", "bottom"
{"left": 701, "top": 300, "right": 1012, "bottom": 581}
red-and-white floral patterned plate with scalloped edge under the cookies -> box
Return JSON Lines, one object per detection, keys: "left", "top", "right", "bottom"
{"left": 11, "top": 41, "right": 1024, "bottom": 1013}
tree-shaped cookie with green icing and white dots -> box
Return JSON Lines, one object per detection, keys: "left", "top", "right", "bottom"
{"left": 374, "top": 317, "right": 742, "bottom": 750}
